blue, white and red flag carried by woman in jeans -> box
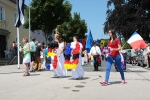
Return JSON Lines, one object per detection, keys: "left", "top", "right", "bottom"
{"left": 127, "top": 32, "right": 147, "bottom": 50}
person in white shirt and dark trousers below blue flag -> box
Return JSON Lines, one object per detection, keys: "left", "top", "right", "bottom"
{"left": 89, "top": 42, "right": 101, "bottom": 71}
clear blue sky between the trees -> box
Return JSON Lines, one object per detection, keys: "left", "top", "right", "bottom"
{"left": 25, "top": 0, "right": 108, "bottom": 40}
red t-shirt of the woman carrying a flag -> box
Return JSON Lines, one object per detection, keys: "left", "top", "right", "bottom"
{"left": 108, "top": 38, "right": 120, "bottom": 57}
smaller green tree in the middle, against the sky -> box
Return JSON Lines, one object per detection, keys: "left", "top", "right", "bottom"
{"left": 58, "top": 13, "right": 87, "bottom": 42}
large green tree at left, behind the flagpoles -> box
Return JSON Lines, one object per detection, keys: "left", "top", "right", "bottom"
{"left": 24, "top": 0, "right": 72, "bottom": 44}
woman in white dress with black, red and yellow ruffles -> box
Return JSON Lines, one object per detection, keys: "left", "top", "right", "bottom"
{"left": 64, "top": 36, "right": 84, "bottom": 79}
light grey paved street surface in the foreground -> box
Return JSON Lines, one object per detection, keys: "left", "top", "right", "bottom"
{"left": 0, "top": 61, "right": 150, "bottom": 100}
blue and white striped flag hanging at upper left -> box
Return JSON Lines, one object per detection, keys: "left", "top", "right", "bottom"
{"left": 15, "top": 0, "right": 25, "bottom": 27}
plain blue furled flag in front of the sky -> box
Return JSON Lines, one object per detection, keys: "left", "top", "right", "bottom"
{"left": 85, "top": 30, "right": 93, "bottom": 52}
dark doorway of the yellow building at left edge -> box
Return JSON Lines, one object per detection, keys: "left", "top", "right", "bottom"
{"left": 0, "top": 35, "right": 6, "bottom": 58}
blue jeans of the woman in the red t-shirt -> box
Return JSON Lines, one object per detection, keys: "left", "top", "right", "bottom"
{"left": 105, "top": 55, "right": 125, "bottom": 82}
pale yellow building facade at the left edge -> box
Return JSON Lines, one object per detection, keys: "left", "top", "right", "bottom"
{"left": 0, "top": 0, "right": 29, "bottom": 58}
